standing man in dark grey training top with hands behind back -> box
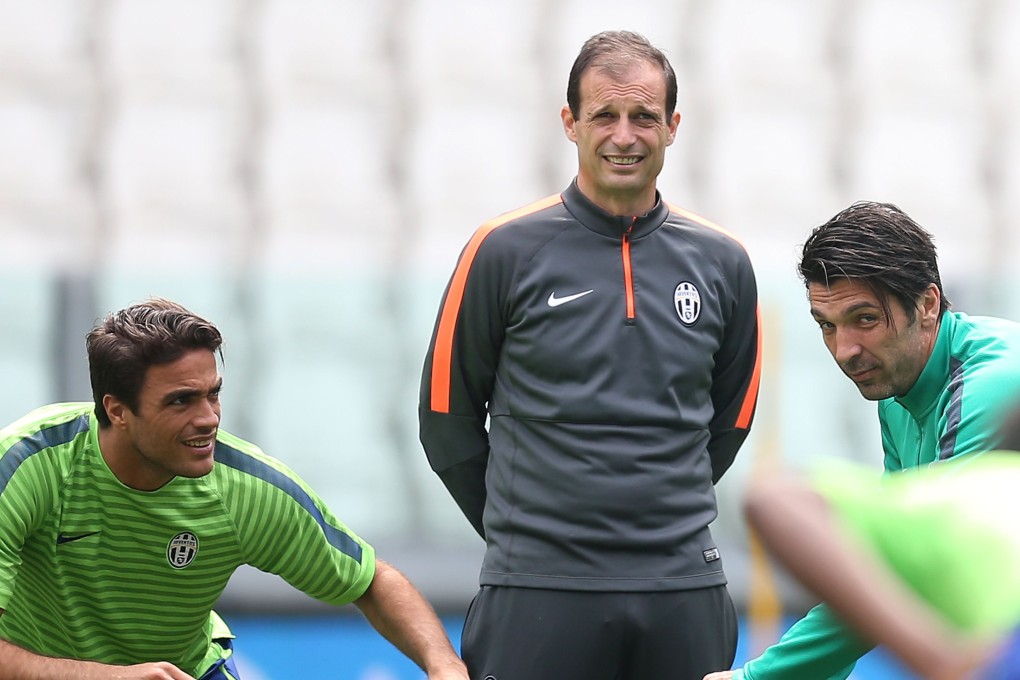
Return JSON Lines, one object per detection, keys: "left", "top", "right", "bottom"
{"left": 420, "top": 32, "right": 761, "bottom": 680}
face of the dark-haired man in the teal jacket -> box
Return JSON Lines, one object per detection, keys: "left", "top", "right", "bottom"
{"left": 808, "top": 278, "right": 939, "bottom": 401}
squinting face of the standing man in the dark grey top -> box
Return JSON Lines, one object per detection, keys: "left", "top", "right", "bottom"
{"left": 560, "top": 60, "right": 680, "bottom": 215}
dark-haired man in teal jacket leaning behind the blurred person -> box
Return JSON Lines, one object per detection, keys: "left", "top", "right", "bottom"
{"left": 705, "top": 202, "right": 1020, "bottom": 680}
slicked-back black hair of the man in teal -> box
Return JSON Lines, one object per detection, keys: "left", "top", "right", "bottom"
{"left": 799, "top": 201, "right": 950, "bottom": 323}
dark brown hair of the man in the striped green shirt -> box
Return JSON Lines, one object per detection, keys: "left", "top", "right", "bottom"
{"left": 85, "top": 298, "right": 223, "bottom": 427}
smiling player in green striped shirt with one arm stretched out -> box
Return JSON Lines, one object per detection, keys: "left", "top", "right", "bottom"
{"left": 0, "top": 299, "right": 467, "bottom": 680}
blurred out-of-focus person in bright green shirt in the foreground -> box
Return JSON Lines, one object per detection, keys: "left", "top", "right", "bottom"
{"left": 746, "top": 403, "right": 1020, "bottom": 680}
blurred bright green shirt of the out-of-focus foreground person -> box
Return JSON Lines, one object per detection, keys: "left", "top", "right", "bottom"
{"left": 813, "top": 452, "right": 1020, "bottom": 634}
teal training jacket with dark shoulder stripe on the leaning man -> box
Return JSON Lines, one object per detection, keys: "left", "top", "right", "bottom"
{"left": 733, "top": 311, "right": 1020, "bottom": 680}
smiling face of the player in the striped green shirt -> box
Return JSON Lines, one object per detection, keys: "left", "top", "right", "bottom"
{"left": 99, "top": 350, "right": 223, "bottom": 490}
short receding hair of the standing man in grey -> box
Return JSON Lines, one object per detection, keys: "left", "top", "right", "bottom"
{"left": 567, "top": 31, "right": 676, "bottom": 119}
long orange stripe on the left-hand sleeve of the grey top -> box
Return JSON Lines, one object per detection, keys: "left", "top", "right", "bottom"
{"left": 430, "top": 194, "right": 563, "bottom": 413}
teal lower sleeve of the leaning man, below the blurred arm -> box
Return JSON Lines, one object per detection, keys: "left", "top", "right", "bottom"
{"left": 734, "top": 605, "right": 871, "bottom": 680}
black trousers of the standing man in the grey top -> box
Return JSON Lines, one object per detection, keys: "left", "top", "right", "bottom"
{"left": 461, "top": 585, "right": 737, "bottom": 680}
